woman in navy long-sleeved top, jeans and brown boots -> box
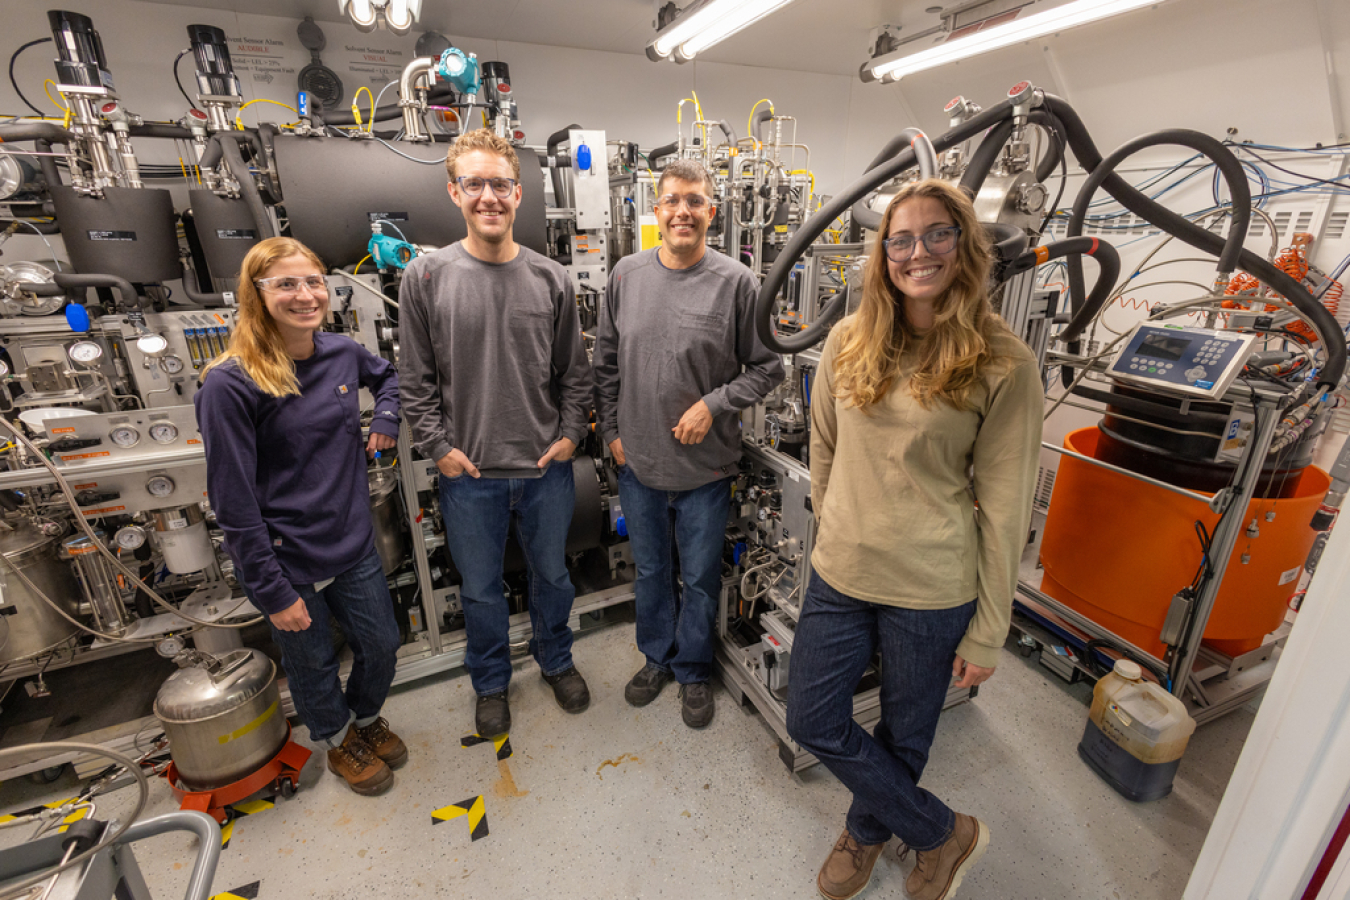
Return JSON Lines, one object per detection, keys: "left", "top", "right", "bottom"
{"left": 193, "top": 237, "right": 408, "bottom": 795}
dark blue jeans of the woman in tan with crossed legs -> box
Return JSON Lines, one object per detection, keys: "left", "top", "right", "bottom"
{"left": 787, "top": 575, "right": 975, "bottom": 850}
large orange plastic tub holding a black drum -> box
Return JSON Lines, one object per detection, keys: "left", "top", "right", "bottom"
{"left": 1041, "top": 428, "right": 1331, "bottom": 656}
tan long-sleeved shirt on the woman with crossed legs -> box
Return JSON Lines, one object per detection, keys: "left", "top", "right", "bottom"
{"left": 810, "top": 320, "right": 1045, "bottom": 668}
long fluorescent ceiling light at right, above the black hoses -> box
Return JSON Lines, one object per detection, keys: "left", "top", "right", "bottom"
{"left": 864, "top": 0, "right": 1161, "bottom": 81}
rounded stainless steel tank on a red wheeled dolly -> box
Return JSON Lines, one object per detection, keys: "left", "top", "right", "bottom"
{"left": 154, "top": 648, "right": 286, "bottom": 791}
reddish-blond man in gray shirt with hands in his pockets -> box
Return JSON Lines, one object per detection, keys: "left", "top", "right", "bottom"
{"left": 398, "top": 130, "right": 591, "bottom": 737}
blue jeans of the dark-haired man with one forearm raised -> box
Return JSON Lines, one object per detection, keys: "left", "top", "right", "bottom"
{"left": 618, "top": 466, "right": 732, "bottom": 684}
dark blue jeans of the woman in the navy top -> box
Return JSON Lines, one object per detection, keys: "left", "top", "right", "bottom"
{"left": 271, "top": 546, "right": 398, "bottom": 743}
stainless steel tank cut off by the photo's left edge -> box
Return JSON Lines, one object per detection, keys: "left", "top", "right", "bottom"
{"left": 0, "top": 522, "right": 80, "bottom": 663}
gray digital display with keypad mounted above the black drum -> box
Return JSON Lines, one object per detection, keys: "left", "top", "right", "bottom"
{"left": 1106, "top": 322, "right": 1257, "bottom": 399}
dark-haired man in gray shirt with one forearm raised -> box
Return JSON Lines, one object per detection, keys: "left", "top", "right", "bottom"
{"left": 594, "top": 161, "right": 783, "bottom": 729}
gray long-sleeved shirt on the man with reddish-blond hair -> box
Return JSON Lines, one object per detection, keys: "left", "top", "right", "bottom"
{"left": 398, "top": 243, "right": 591, "bottom": 478}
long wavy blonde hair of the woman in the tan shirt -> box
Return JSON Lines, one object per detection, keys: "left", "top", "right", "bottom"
{"left": 834, "top": 179, "right": 1007, "bottom": 412}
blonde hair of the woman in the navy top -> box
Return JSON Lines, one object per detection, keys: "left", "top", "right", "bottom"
{"left": 200, "top": 237, "right": 324, "bottom": 397}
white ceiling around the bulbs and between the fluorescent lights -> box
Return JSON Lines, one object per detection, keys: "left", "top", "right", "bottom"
{"left": 142, "top": 0, "right": 956, "bottom": 76}
